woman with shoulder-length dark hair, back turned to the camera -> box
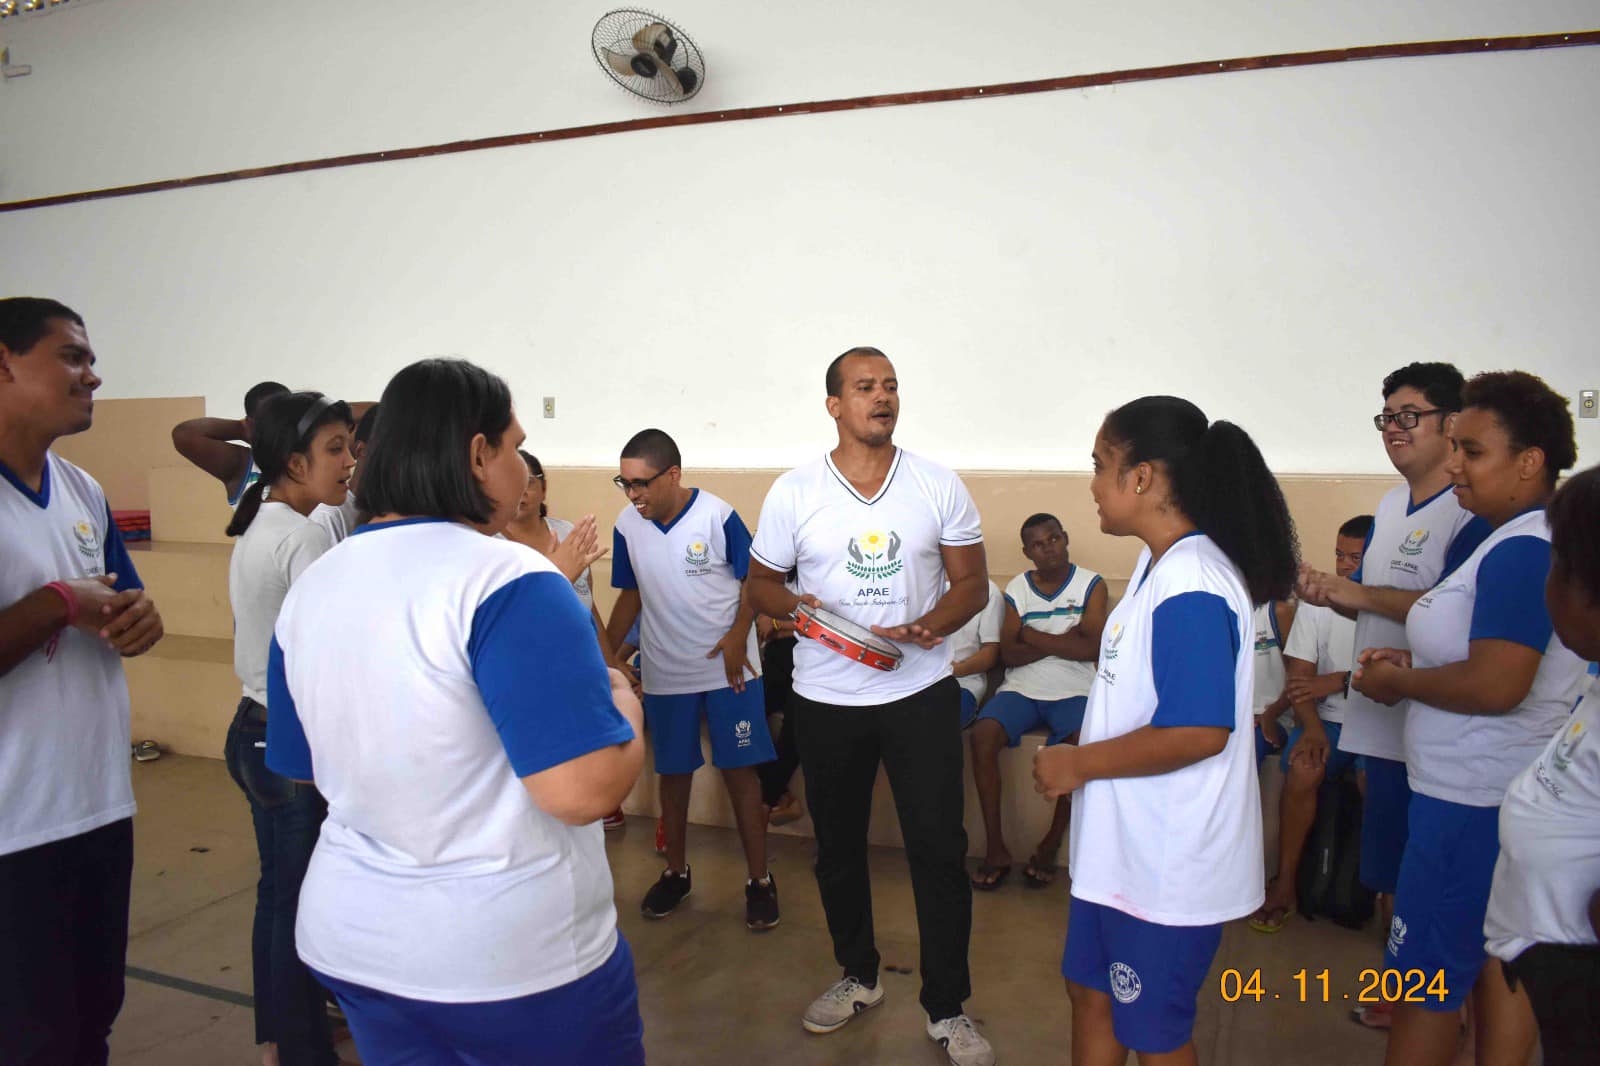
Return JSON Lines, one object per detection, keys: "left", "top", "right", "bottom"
{"left": 267, "top": 359, "right": 643, "bottom": 1066}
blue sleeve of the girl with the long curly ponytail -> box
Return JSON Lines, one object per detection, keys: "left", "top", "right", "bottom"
{"left": 1150, "top": 592, "right": 1238, "bottom": 730}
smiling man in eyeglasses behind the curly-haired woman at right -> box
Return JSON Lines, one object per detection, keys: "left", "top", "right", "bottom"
{"left": 1299, "top": 363, "right": 1488, "bottom": 1026}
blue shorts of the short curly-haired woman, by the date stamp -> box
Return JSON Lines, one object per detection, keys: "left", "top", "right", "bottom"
{"left": 1384, "top": 794, "right": 1499, "bottom": 1010}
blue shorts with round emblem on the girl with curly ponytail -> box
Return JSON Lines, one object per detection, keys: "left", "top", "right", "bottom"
{"left": 1061, "top": 896, "right": 1222, "bottom": 1055}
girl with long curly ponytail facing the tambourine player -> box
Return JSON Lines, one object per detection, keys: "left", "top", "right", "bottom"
{"left": 1034, "top": 395, "right": 1298, "bottom": 1061}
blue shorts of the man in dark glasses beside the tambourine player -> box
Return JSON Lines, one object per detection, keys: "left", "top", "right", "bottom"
{"left": 645, "top": 677, "right": 778, "bottom": 773}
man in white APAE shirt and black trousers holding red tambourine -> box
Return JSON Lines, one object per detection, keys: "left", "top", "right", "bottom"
{"left": 747, "top": 347, "right": 995, "bottom": 1066}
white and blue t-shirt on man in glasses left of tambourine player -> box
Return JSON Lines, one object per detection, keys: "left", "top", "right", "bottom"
{"left": 611, "top": 488, "right": 762, "bottom": 696}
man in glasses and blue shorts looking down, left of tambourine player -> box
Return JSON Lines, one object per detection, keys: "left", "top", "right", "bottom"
{"left": 606, "top": 429, "right": 778, "bottom": 932}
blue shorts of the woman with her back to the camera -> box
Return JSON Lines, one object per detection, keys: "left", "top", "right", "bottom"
{"left": 308, "top": 935, "right": 645, "bottom": 1066}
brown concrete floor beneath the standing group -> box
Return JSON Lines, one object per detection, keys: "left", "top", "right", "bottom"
{"left": 112, "top": 755, "right": 1384, "bottom": 1066}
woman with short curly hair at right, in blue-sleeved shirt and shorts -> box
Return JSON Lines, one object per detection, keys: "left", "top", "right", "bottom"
{"left": 1354, "top": 371, "right": 1584, "bottom": 1066}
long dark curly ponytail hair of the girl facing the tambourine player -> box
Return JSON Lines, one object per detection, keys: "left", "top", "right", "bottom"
{"left": 1102, "top": 395, "right": 1299, "bottom": 603}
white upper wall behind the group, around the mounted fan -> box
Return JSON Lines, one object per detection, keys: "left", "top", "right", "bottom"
{"left": 0, "top": 0, "right": 1600, "bottom": 472}
